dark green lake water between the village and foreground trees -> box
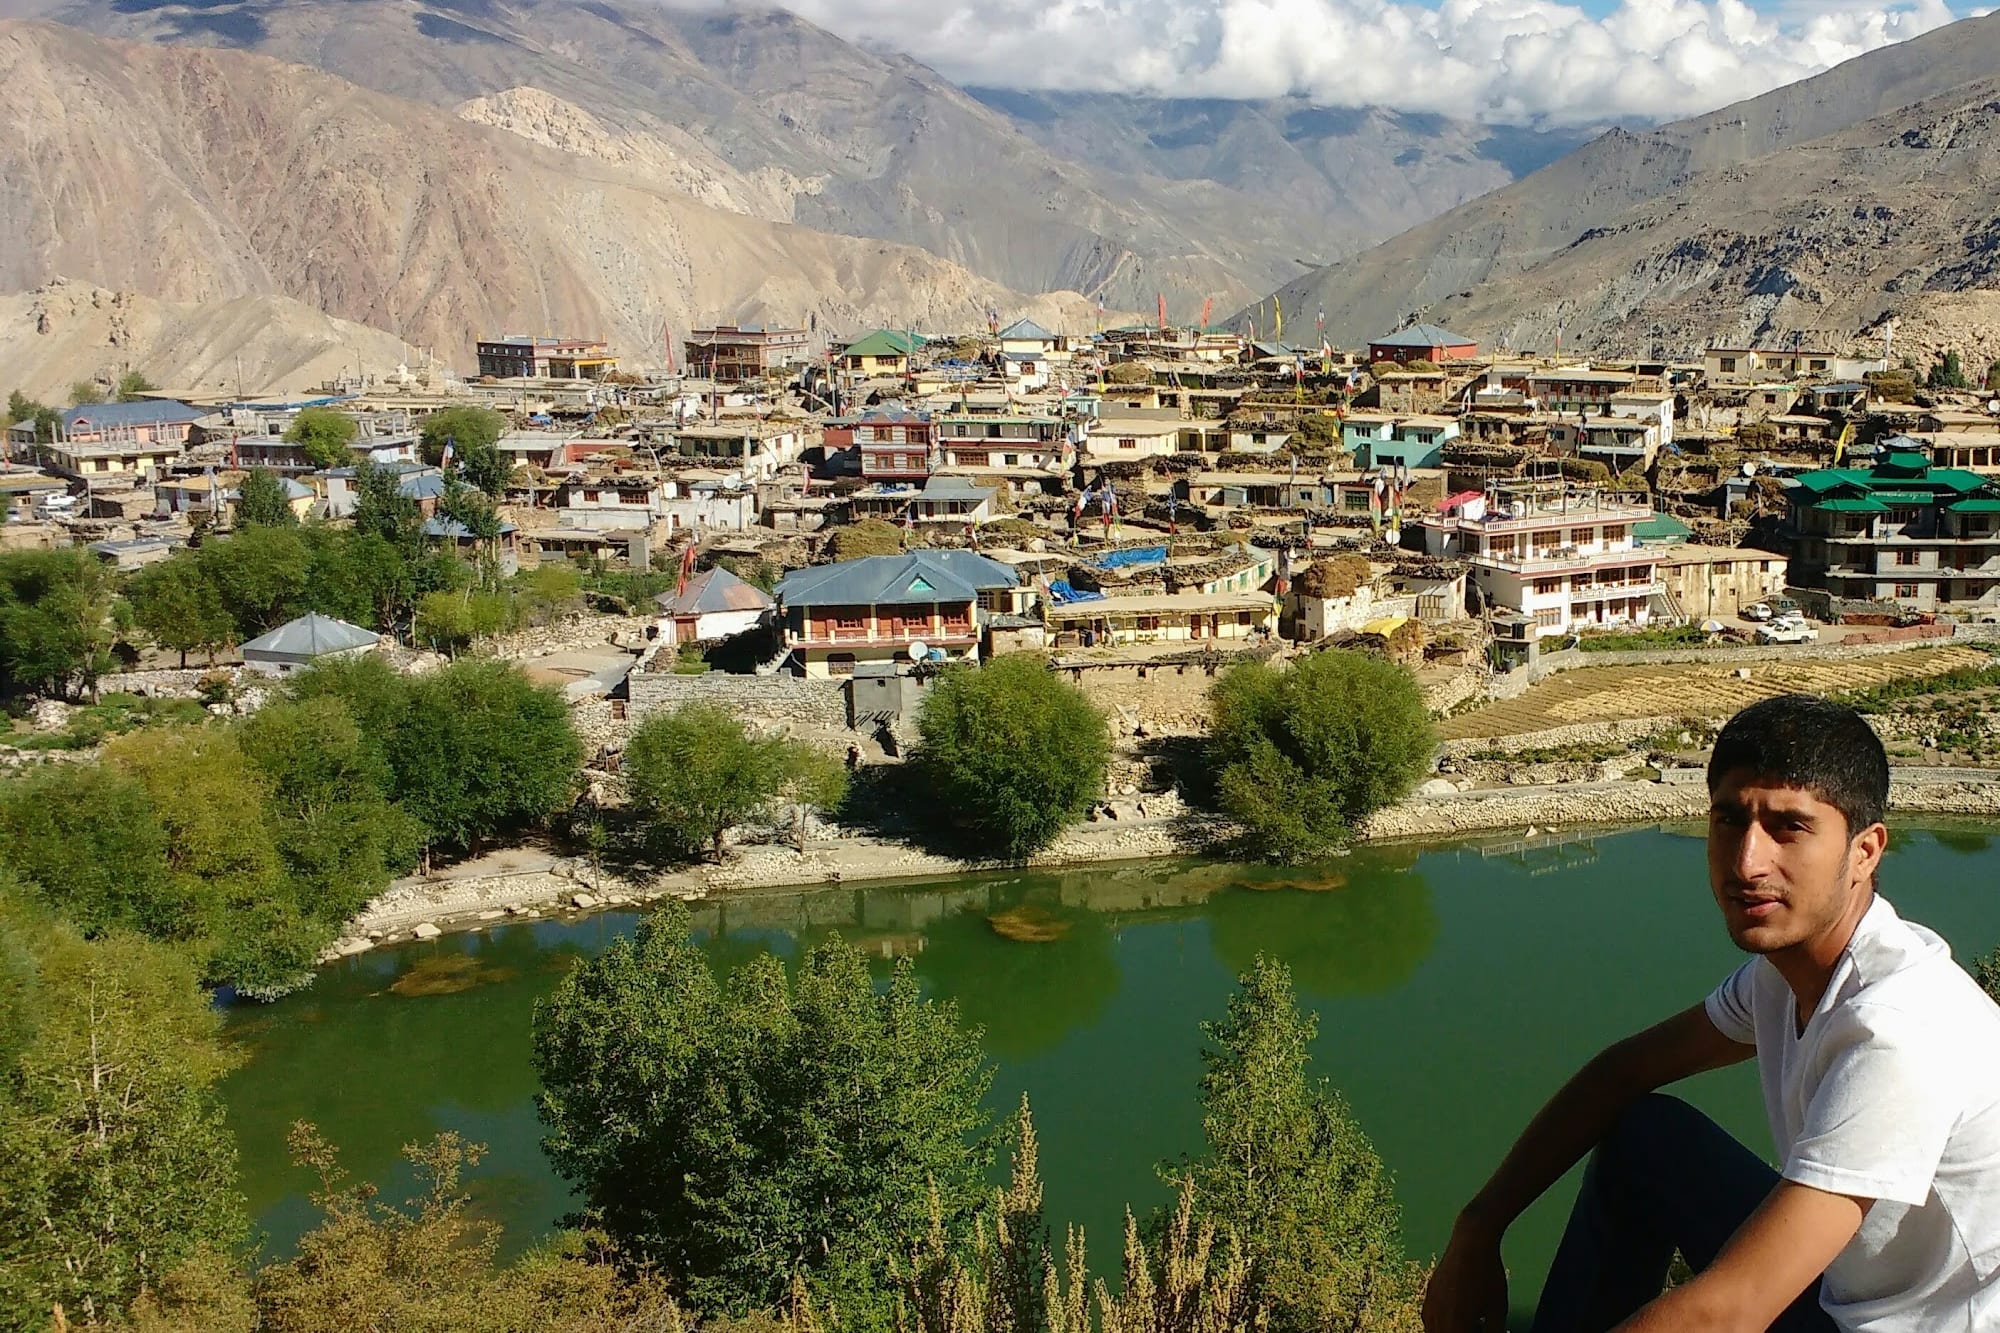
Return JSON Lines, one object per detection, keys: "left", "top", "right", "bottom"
{"left": 226, "top": 827, "right": 2000, "bottom": 1305}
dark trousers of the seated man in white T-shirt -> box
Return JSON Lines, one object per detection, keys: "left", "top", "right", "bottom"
{"left": 1534, "top": 1093, "right": 1834, "bottom": 1333}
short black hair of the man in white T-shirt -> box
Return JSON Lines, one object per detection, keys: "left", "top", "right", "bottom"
{"left": 1708, "top": 695, "right": 1888, "bottom": 837}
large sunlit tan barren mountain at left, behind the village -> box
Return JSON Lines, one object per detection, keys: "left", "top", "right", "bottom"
{"left": 0, "top": 22, "right": 1128, "bottom": 370}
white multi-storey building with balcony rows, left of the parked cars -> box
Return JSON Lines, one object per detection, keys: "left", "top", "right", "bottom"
{"left": 1422, "top": 484, "right": 1670, "bottom": 636}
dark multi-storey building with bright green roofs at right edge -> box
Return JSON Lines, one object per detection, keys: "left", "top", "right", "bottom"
{"left": 1786, "top": 448, "right": 2000, "bottom": 614}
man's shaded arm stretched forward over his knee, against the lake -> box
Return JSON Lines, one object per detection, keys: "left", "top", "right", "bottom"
{"left": 1424, "top": 1005, "right": 1756, "bottom": 1333}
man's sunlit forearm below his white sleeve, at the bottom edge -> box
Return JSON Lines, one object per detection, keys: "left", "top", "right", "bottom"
{"left": 1616, "top": 1181, "right": 1872, "bottom": 1333}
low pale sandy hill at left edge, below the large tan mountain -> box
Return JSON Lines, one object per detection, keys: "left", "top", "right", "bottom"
{"left": 0, "top": 278, "right": 410, "bottom": 400}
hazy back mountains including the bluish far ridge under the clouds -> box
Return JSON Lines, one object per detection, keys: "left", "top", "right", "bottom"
{"left": 39, "top": 0, "right": 1574, "bottom": 318}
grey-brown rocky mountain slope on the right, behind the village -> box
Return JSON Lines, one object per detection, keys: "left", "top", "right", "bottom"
{"left": 1256, "top": 7, "right": 2000, "bottom": 352}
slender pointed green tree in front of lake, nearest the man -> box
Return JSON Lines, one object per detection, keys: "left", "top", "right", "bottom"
{"left": 1160, "top": 957, "right": 1422, "bottom": 1333}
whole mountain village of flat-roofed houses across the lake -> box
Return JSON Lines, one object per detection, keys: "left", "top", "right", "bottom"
{"left": 11, "top": 314, "right": 2000, "bottom": 875}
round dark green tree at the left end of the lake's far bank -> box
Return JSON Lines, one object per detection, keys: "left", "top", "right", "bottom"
{"left": 388, "top": 660, "right": 582, "bottom": 847}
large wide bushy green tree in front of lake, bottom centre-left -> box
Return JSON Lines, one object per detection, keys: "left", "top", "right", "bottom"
{"left": 534, "top": 905, "right": 990, "bottom": 1329}
